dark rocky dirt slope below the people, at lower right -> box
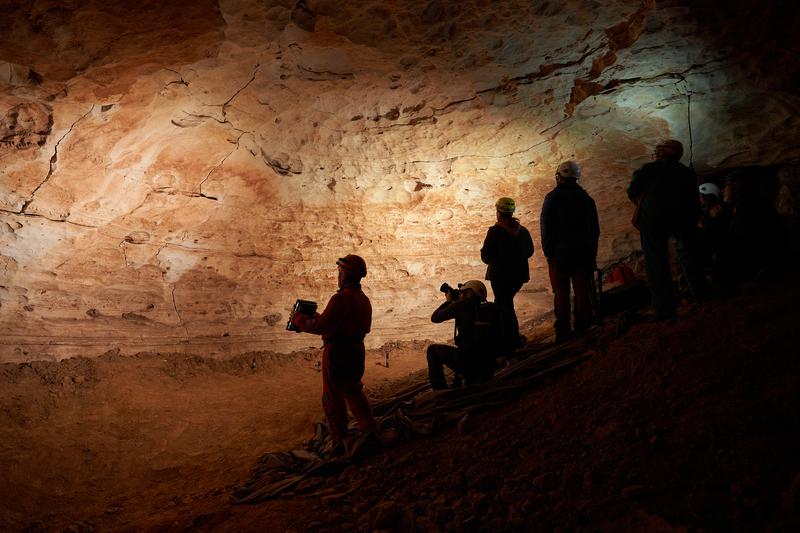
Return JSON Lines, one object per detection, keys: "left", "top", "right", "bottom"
{"left": 205, "top": 276, "right": 800, "bottom": 532}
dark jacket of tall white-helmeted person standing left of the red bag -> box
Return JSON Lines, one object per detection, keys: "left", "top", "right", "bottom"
{"left": 540, "top": 181, "right": 600, "bottom": 268}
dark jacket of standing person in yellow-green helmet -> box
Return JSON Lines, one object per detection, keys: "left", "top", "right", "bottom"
{"left": 481, "top": 218, "right": 533, "bottom": 284}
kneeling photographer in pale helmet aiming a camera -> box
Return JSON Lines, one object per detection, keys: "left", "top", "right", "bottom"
{"left": 428, "top": 280, "right": 505, "bottom": 390}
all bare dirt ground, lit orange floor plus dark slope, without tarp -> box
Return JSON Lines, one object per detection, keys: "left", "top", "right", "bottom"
{"left": 0, "top": 280, "right": 800, "bottom": 531}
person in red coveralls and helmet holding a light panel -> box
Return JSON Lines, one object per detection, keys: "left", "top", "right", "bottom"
{"left": 289, "top": 254, "right": 381, "bottom": 456}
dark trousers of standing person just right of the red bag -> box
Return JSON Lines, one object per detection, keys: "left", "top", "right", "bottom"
{"left": 639, "top": 224, "right": 703, "bottom": 319}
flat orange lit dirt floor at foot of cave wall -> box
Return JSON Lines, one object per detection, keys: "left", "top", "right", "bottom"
{"left": 0, "top": 334, "right": 434, "bottom": 531}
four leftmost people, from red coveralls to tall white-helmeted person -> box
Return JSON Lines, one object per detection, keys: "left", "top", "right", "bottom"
{"left": 282, "top": 157, "right": 600, "bottom": 456}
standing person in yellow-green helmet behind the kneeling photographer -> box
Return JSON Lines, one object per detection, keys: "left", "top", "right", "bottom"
{"left": 481, "top": 197, "right": 533, "bottom": 349}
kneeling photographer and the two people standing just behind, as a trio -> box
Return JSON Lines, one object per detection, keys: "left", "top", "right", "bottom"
{"left": 427, "top": 161, "right": 600, "bottom": 389}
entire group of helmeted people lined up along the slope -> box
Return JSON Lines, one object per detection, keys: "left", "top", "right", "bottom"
{"left": 290, "top": 140, "right": 780, "bottom": 455}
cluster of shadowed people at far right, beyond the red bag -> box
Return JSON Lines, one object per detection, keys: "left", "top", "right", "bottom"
{"left": 627, "top": 140, "right": 782, "bottom": 320}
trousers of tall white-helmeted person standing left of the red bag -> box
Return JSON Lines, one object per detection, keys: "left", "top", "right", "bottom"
{"left": 548, "top": 263, "right": 592, "bottom": 341}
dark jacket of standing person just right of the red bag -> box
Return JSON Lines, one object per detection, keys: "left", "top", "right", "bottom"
{"left": 628, "top": 159, "right": 700, "bottom": 234}
